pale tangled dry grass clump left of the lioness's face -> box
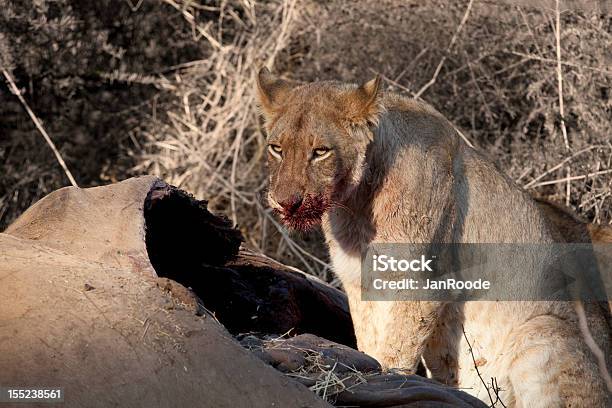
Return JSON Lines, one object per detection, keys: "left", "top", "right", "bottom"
{"left": 135, "top": 0, "right": 334, "bottom": 280}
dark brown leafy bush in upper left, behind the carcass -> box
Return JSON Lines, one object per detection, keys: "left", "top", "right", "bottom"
{"left": 0, "top": 0, "right": 207, "bottom": 230}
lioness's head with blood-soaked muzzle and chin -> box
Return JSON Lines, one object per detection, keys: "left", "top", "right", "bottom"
{"left": 258, "top": 68, "right": 382, "bottom": 230}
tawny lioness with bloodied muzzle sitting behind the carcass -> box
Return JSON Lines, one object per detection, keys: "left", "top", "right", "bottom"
{"left": 258, "top": 69, "right": 610, "bottom": 407}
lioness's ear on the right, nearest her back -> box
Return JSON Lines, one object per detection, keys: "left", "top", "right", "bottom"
{"left": 347, "top": 75, "right": 383, "bottom": 124}
